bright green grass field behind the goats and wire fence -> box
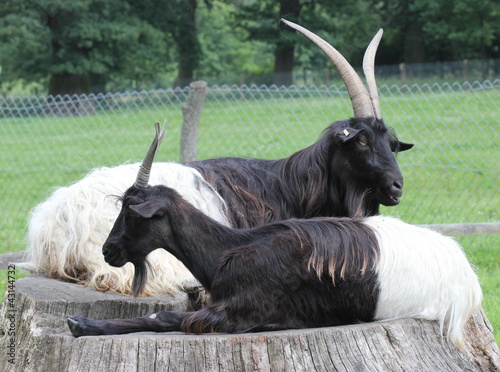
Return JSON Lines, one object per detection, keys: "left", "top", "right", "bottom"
{"left": 0, "top": 84, "right": 500, "bottom": 342}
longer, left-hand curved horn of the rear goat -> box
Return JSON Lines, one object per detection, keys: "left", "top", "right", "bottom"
{"left": 281, "top": 19, "right": 374, "bottom": 117}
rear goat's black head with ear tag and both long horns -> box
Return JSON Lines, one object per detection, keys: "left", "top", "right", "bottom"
{"left": 282, "top": 20, "right": 413, "bottom": 215}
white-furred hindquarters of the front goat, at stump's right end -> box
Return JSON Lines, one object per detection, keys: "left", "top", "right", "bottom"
{"left": 365, "top": 216, "right": 482, "bottom": 349}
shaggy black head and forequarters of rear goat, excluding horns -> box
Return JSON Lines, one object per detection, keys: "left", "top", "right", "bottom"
{"left": 187, "top": 118, "right": 413, "bottom": 228}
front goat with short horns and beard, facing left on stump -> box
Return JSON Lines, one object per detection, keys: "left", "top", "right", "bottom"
{"left": 68, "top": 123, "right": 482, "bottom": 347}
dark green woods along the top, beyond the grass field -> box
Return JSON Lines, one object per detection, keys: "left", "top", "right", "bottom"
{"left": 0, "top": 0, "right": 500, "bottom": 94}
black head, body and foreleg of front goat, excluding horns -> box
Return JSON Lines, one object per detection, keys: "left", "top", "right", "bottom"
{"left": 68, "top": 186, "right": 379, "bottom": 336}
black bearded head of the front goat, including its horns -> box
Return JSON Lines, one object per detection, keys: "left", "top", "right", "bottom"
{"left": 102, "top": 123, "right": 169, "bottom": 295}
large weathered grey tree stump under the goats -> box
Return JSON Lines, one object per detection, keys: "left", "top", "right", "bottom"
{"left": 0, "top": 276, "right": 500, "bottom": 372}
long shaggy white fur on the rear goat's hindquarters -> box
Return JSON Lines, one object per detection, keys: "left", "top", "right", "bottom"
{"left": 20, "top": 163, "right": 228, "bottom": 295}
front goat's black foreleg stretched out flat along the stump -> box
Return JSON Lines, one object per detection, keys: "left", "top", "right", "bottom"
{"left": 68, "top": 311, "right": 191, "bottom": 337}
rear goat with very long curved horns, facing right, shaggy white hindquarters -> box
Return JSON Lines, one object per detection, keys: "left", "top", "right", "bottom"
{"left": 24, "top": 21, "right": 412, "bottom": 295}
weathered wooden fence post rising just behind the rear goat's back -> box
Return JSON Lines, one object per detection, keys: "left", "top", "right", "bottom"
{"left": 181, "top": 81, "right": 207, "bottom": 162}
